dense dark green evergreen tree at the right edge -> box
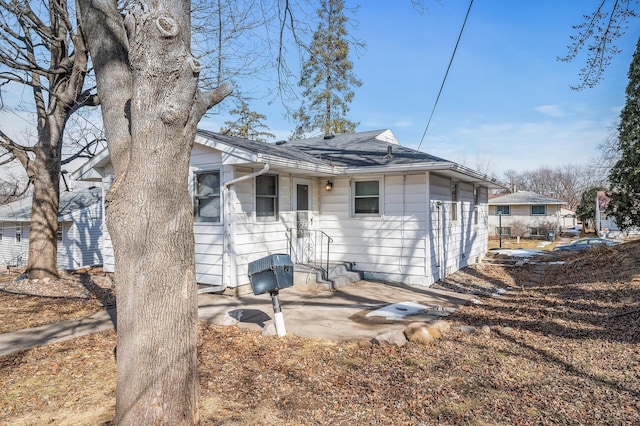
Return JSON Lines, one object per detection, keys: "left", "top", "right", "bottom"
{"left": 607, "top": 40, "right": 640, "bottom": 230}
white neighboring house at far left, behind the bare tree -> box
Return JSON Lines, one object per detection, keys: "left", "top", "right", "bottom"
{"left": 0, "top": 188, "right": 102, "bottom": 270}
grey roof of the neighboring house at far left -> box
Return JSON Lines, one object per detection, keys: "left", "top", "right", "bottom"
{"left": 0, "top": 188, "right": 102, "bottom": 222}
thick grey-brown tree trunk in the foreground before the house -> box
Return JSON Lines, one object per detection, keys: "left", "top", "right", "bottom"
{"left": 80, "top": 0, "right": 230, "bottom": 425}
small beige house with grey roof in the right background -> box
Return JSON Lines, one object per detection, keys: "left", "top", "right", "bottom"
{"left": 489, "top": 191, "right": 565, "bottom": 238}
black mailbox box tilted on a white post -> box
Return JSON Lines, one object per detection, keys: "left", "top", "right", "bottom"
{"left": 248, "top": 254, "right": 293, "bottom": 295}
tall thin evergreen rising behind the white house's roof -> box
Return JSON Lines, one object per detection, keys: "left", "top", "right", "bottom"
{"left": 293, "top": 0, "right": 362, "bottom": 135}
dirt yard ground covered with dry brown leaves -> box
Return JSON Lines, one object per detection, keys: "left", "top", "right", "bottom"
{"left": 0, "top": 242, "right": 640, "bottom": 425}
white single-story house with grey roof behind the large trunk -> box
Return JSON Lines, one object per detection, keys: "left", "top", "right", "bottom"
{"left": 73, "top": 130, "right": 503, "bottom": 292}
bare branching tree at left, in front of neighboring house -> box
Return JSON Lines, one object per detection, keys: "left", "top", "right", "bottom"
{"left": 0, "top": 0, "right": 97, "bottom": 278}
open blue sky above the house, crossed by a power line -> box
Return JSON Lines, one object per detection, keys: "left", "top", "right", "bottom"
{"left": 202, "top": 0, "right": 640, "bottom": 177}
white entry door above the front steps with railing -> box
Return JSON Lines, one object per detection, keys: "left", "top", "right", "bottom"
{"left": 292, "top": 179, "right": 315, "bottom": 263}
